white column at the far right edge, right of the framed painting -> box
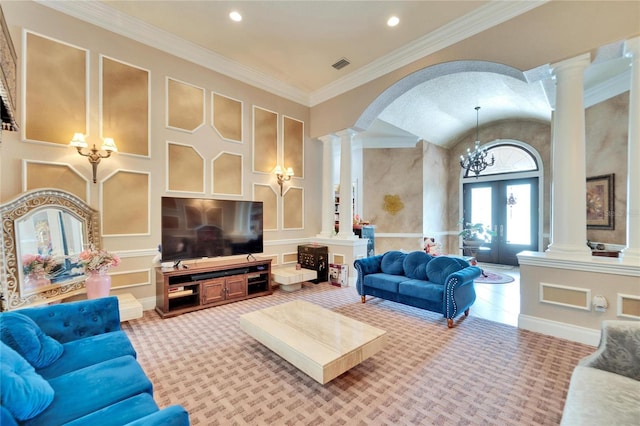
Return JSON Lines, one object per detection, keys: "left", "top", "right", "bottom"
{"left": 622, "top": 37, "right": 640, "bottom": 263}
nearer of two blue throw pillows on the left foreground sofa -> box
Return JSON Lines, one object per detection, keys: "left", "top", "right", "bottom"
{"left": 0, "top": 342, "right": 54, "bottom": 421}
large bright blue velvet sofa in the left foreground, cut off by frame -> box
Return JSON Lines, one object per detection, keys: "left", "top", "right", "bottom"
{"left": 0, "top": 297, "right": 189, "bottom": 426}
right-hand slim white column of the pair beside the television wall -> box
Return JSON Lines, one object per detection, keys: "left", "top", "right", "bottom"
{"left": 338, "top": 129, "right": 357, "bottom": 240}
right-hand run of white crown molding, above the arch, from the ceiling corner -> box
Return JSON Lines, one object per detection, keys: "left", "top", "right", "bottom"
{"left": 310, "top": 0, "right": 549, "bottom": 106}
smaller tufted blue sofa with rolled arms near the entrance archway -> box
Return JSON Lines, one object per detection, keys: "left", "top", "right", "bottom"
{"left": 354, "top": 251, "right": 482, "bottom": 328}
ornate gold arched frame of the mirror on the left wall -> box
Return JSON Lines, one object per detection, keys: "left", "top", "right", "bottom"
{"left": 0, "top": 189, "right": 101, "bottom": 311}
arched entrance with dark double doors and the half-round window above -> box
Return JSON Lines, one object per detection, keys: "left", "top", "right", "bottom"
{"left": 461, "top": 140, "right": 543, "bottom": 265}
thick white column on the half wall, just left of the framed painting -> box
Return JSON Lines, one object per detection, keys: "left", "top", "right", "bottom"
{"left": 547, "top": 53, "right": 591, "bottom": 257}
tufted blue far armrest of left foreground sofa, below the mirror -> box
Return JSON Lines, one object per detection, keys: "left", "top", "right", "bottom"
{"left": 18, "top": 296, "right": 120, "bottom": 343}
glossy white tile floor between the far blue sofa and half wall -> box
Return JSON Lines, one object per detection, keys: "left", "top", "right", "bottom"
{"left": 470, "top": 263, "right": 520, "bottom": 327}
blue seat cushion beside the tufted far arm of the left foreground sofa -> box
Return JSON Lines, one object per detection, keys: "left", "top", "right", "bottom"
{"left": 37, "top": 331, "right": 136, "bottom": 379}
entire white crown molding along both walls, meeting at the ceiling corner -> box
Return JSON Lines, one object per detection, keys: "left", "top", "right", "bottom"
{"left": 35, "top": 0, "right": 549, "bottom": 106}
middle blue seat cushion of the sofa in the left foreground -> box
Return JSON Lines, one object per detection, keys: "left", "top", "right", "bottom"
{"left": 22, "top": 355, "right": 153, "bottom": 426}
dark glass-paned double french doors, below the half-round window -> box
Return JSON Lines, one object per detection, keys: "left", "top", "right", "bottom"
{"left": 463, "top": 178, "right": 538, "bottom": 265}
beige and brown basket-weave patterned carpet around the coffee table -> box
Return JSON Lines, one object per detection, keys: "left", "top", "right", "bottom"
{"left": 123, "top": 283, "right": 594, "bottom": 425}
